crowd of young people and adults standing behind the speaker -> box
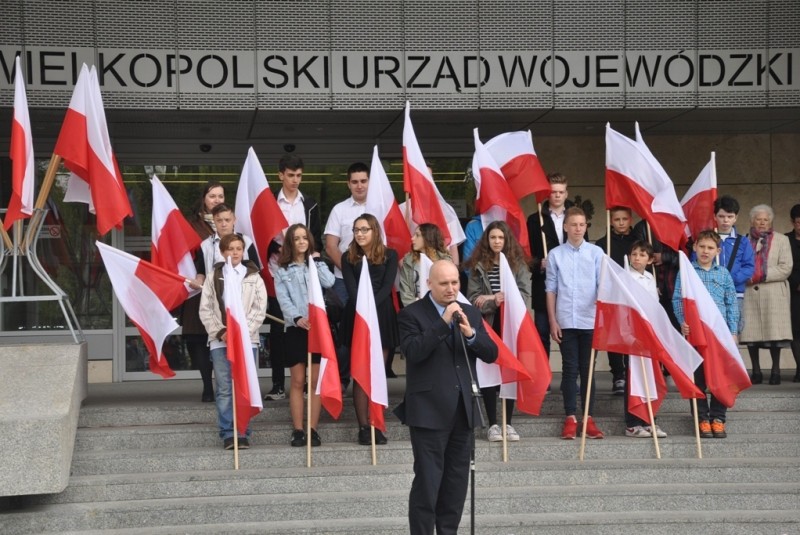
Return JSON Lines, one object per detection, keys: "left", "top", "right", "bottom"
{"left": 181, "top": 154, "right": 800, "bottom": 456}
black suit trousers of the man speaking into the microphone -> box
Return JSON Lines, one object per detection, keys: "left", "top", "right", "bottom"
{"left": 408, "top": 399, "right": 472, "bottom": 535}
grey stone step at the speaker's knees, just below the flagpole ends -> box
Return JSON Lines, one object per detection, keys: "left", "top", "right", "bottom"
{"left": 26, "top": 458, "right": 800, "bottom": 505}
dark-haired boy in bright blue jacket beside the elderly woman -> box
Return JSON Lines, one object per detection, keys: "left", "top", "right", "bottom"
{"left": 714, "top": 195, "right": 756, "bottom": 334}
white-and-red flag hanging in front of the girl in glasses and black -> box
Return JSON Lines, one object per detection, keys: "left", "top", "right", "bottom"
{"left": 350, "top": 256, "right": 389, "bottom": 433}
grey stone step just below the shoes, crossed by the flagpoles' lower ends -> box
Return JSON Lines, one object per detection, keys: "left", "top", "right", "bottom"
{"left": 72, "top": 434, "right": 800, "bottom": 476}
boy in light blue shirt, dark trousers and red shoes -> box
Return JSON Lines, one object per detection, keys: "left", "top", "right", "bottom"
{"left": 545, "top": 207, "right": 604, "bottom": 440}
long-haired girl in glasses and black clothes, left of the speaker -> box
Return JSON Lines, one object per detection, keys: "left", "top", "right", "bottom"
{"left": 342, "top": 214, "right": 400, "bottom": 445}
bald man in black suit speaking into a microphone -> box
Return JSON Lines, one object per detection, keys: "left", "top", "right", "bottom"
{"left": 395, "top": 260, "right": 497, "bottom": 535}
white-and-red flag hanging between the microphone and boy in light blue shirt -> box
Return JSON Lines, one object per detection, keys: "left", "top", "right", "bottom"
{"left": 500, "top": 253, "right": 553, "bottom": 415}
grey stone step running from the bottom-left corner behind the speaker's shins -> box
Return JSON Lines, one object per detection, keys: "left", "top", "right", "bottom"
{"left": 3, "top": 482, "right": 800, "bottom": 533}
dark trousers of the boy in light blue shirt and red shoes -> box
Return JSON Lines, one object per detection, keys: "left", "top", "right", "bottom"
{"left": 561, "top": 329, "right": 595, "bottom": 416}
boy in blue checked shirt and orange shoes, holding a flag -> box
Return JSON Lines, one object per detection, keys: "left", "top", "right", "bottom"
{"left": 672, "top": 230, "right": 739, "bottom": 438}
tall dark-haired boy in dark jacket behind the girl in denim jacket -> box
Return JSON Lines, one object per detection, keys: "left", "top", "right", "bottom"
{"left": 264, "top": 154, "right": 322, "bottom": 401}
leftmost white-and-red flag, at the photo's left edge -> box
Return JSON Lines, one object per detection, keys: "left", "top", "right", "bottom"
{"left": 3, "top": 56, "right": 34, "bottom": 230}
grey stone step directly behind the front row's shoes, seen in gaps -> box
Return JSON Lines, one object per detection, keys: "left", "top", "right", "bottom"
{"left": 70, "top": 411, "right": 800, "bottom": 452}
